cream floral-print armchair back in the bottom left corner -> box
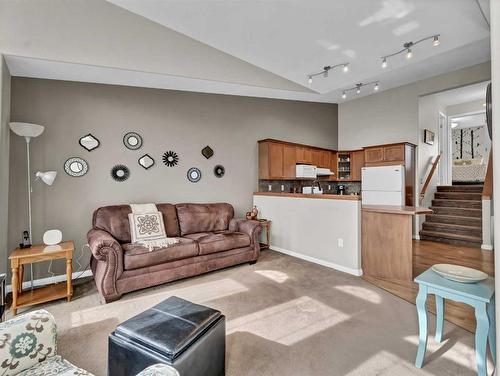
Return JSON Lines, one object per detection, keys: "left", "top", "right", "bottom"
{"left": 0, "top": 309, "right": 57, "bottom": 374}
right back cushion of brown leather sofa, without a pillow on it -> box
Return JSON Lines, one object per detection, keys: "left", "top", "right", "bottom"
{"left": 175, "top": 203, "right": 234, "bottom": 236}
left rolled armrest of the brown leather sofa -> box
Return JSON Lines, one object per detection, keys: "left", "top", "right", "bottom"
{"left": 87, "top": 229, "right": 123, "bottom": 302}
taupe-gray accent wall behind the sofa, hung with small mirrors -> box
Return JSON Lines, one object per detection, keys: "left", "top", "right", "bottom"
{"left": 8, "top": 77, "right": 338, "bottom": 278}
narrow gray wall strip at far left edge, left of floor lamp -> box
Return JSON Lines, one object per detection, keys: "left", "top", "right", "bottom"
{"left": 0, "top": 54, "right": 10, "bottom": 273}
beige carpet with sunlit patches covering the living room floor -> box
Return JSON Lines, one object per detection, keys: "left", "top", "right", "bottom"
{"left": 7, "top": 251, "right": 492, "bottom": 376}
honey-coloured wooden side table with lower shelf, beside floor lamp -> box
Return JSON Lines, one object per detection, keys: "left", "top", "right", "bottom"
{"left": 9, "top": 241, "right": 75, "bottom": 315}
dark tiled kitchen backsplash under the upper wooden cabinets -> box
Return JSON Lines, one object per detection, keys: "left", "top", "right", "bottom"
{"left": 259, "top": 180, "right": 361, "bottom": 195}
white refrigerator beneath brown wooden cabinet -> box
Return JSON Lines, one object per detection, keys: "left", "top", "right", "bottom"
{"left": 361, "top": 165, "right": 405, "bottom": 206}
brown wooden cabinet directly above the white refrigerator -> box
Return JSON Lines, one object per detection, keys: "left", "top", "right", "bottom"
{"left": 364, "top": 142, "right": 415, "bottom": 167}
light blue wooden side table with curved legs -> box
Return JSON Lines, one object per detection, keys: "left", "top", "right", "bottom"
{"left": 415, "top": 269, "right": 496, "bottom": 376}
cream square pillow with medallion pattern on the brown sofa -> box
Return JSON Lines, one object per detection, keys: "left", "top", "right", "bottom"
{"left": 128, "top": 212, "right": 167, "bottom": 243}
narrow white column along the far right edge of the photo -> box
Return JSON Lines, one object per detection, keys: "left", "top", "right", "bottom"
{"left": 490, "top": 0, "right": 500, "bottom": 368}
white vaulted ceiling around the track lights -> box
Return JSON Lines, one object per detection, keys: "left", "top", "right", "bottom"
{"left": 0, "top": 0, "right": 490, "bottom": 103}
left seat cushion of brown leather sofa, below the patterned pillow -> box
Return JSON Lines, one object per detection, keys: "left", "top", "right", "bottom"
{"left": 122, "top": 238, "right": 198, "bottom": 270}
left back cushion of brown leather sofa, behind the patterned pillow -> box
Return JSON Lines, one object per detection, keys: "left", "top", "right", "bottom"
{"left": 92, "top": 204, "right": 180, "bottom": 243}
